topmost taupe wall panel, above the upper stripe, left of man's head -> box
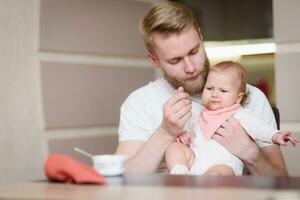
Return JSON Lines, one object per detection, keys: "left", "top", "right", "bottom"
{"left": 40, "top": 0, "right": 149, "bottom": 56}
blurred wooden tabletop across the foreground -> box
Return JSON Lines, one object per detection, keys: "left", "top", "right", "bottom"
{"left": 0, "top": 174, "right": 300, "bottom": 200}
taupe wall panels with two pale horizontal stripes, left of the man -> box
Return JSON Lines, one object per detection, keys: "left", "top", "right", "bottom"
{"left": 40, "top": 0, "right": 155, "bottom": 160}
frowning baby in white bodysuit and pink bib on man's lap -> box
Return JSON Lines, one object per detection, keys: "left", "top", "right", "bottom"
{"left": 165, "top": 61, "right": 298, "bottom": 175}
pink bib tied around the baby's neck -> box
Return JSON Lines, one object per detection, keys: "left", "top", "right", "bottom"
{"left": 199, "top": 104, "right": 242, "bottom": 140}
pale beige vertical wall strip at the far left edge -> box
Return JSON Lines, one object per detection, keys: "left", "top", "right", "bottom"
{"left": 0, "top": 0, "right": 47, "bottom": 184}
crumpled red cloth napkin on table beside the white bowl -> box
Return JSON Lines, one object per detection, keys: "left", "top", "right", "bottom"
{"left": 44, "top": 154, "right": 107, "bottom": 185}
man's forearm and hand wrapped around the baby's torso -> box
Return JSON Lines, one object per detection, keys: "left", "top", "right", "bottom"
{"left": 213, "top": 118, "right": 288, "bottom": 176}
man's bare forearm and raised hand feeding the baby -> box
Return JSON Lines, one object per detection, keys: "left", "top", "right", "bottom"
{"left": 116, "top": 88, "right": 192, "bottom": 173}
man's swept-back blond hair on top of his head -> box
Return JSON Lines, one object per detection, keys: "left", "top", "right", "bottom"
{"left": 139, "top": 1, "right": 202, "bottom": 53}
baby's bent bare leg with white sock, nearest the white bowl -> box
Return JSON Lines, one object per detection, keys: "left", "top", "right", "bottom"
{"left": 165, "top": 142, "right": 194, "bottom": 174}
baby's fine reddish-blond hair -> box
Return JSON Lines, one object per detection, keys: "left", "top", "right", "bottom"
{"left": 210, "top": 61, "right": 248, "bottom": 105}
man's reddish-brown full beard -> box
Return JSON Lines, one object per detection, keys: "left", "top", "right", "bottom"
{"left": 163, "top": 55, "right": 209, "bottom": 96}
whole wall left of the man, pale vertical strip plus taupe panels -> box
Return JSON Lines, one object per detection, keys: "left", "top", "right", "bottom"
{"left": 0, "top": 0, "right": 155, "bottom": 184}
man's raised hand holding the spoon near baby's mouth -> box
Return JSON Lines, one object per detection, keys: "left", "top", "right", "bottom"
{"left": 160, "top": 87, "right": 192, "bottom": 138}
